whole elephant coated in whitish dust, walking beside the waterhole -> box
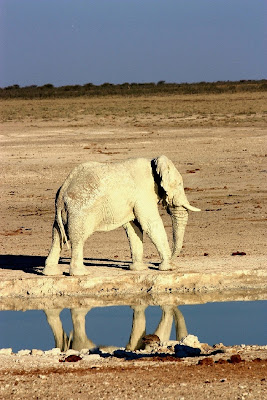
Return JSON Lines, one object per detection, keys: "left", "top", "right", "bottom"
{"left": 43, "top": 156, "right": 200, "bottom": 275}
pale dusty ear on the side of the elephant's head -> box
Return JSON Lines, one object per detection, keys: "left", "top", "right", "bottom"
{"left": 154, "top": 156, "right": 177, "bottom": 205}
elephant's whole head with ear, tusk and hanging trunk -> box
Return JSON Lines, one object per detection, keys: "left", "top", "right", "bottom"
{"left": 151, "top": 156, "right": 200, "bottom": 258}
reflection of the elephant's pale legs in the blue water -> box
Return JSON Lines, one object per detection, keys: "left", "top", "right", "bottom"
{"left": 44, "top": 305, "right": 187, "bottom": 352}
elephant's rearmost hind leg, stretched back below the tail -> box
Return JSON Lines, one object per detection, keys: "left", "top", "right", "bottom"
{"left": 43, "top": 222, "right": 62, "bottom": 275}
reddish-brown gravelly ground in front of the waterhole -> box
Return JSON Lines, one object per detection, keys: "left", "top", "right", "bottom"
{"left": 0, "top": 356, "right": 267, "bottom": 400}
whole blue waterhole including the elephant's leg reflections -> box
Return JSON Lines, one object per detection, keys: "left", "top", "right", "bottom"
{"left": 0, "top": 300, "right": 267, "bottom": 352}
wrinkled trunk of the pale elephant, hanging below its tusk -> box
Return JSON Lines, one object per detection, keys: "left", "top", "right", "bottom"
{"left": 170, "top": 207, "right": 188, "bottom": 258}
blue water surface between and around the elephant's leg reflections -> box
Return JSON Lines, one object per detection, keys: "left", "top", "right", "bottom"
{"left": 0, "top": 301, "right": 267, "bottom": 352}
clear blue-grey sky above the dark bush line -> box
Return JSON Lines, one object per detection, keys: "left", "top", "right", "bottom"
{"left": 0, "top": 0, "right": 267, "bottom": 87}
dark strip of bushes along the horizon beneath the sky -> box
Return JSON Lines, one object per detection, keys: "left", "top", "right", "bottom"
{"left": 0, "top": 79, "right": 267, "bottom": 99}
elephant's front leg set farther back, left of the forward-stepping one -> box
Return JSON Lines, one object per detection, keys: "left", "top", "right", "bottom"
{"left": 123, "top": 220, "right": 147, "bottom": 271}
